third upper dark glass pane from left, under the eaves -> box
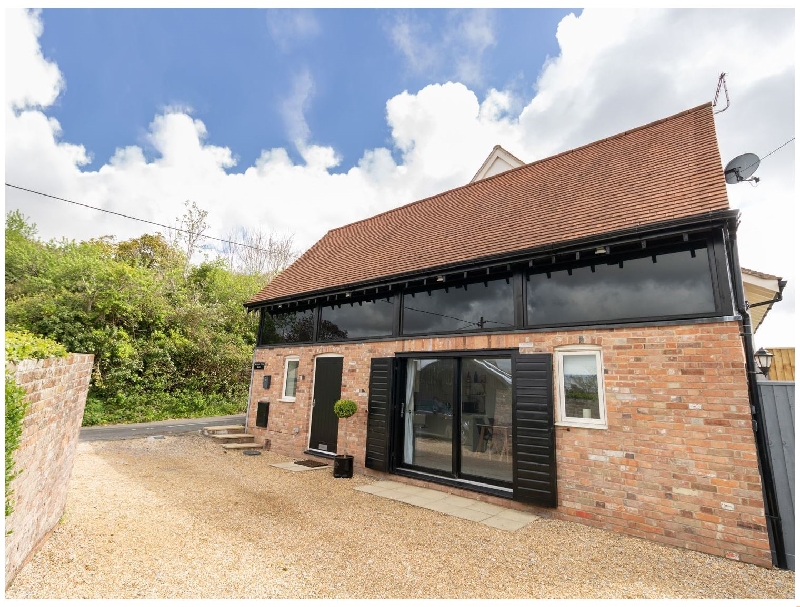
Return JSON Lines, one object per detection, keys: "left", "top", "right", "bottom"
{"left": 403, "top": 278, "right": 514, "bottom": 334}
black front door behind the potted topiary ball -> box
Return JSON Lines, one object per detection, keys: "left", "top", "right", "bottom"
{"left": 308, "top": 356, "right": 343, "bottom": 453}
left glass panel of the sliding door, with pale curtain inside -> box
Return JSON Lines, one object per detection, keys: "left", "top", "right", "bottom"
{"left": 402, "top": 358, "right": 456, "bottom": 473}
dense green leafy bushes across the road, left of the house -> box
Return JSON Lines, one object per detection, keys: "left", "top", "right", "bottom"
{"left": 6, "top": 211, "right": 256, "bottom": 425}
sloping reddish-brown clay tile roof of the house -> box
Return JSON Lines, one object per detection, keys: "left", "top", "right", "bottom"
{"left": 247, "top": 103, "right": 729, "bottom": 305}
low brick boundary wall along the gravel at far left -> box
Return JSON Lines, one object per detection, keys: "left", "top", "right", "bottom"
{"left": 6, "top": 354, "right": 94, "bottom": 588}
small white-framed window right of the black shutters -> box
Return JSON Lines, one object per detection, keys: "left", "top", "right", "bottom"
{"left": 555, "top": 346, "right": 608, "bottom": 428}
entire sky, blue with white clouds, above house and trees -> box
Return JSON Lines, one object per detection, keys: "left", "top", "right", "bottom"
{"left": 5, "top": 8, "right": 796, "bottom": 347}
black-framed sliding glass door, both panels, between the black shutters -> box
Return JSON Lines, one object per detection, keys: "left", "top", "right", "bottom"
{"left": 397, "top": 356, "right": 513, "bottom": 486}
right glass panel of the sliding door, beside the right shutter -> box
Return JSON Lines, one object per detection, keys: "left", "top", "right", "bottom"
{"left": 460, "top": 358, "right": 514, "bottom": 483}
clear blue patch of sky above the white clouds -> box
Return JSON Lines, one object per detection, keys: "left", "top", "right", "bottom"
{"left": 41, "top": 9, "right": 571, "bottom": 171}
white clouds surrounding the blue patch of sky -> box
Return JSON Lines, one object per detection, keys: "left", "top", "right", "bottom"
{"left": 5, "top": 10, "right": 795, "bottom": 346}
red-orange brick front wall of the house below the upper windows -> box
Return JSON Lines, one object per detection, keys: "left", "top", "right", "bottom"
{"left": 248, "top": 322, "right": 771, "bottom": 566}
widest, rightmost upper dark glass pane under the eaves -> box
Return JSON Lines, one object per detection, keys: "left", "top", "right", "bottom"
{"left": 527, "top": 246, "right": 716, "bottom": 326}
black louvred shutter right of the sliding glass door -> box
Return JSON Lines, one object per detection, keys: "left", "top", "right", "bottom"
{"left": 511, "top": 354, "right": 557, "bottom": 507}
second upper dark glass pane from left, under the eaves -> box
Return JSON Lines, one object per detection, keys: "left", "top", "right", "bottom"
{"left": 319, "top": 297, "right": 394, "bottom": 341}
